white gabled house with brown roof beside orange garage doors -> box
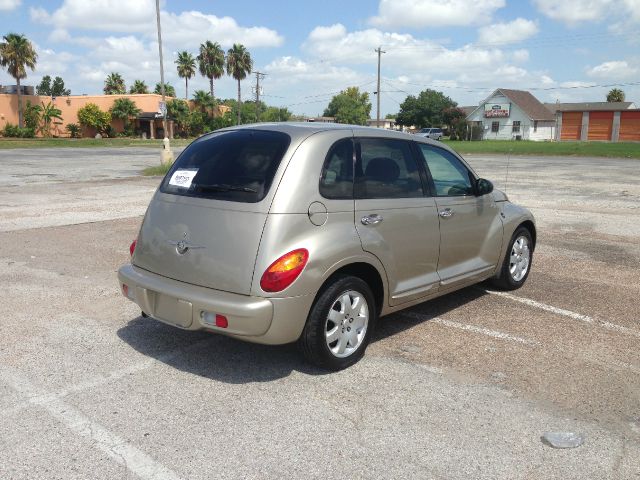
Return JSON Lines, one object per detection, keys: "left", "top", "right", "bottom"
{"left": 467, "top": 88, "right": 556, "bottom": 141}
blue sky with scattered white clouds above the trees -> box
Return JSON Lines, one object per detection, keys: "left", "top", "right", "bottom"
{"left": 0, "top": 0, "right": 640, "bottom": 118}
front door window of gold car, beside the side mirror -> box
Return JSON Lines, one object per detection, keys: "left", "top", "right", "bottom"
{"left": 419, "top": 144, "right": 474, "bottom": 197}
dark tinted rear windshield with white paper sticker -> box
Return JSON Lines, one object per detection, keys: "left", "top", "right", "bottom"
{"left": 160, "top": 129, "right": 291, "bottom": 203}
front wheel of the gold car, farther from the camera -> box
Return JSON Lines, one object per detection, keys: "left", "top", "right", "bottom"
{"left": 491, "top": 227, "right": 533, "bottom": 290}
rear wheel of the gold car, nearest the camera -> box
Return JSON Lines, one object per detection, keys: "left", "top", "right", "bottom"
{"left": 298, "top": 275, "right": 377, "bottom": 371}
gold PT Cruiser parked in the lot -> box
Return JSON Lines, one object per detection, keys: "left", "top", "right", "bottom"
{"left": 118, "top": 123, "right": 536, "bottom": 370}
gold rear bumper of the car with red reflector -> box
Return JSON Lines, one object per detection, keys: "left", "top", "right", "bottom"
{"left": 118, "top": 264, "right": 313, "bottom": 344}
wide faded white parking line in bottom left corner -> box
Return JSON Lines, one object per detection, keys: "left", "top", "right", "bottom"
{"left": 0, "top": 366, "right": 185, "bottom": 480}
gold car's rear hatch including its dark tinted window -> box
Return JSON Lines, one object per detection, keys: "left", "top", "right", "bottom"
{"left": 133, "top": 129, "right": 290, "bottom": 295}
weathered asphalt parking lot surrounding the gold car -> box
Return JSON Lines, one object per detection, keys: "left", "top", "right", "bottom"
{"left": 0, "top": 144, "right": 640, "bottom": 480}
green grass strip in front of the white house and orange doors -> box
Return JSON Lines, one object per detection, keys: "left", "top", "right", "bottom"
{"left": 444, "top": 140, "right": 640, "bottom": 159}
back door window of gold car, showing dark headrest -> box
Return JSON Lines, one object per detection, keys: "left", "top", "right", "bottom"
{"left": 355, "top": 138, "right": 423, "bottom": 198}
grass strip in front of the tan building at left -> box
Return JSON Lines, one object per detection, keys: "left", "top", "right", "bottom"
{"left": 0, "top": 138, "right": 192, "bottom": 149}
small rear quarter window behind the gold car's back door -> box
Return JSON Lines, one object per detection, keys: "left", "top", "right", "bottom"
{"left": 320, "top": 138, "right": 353, "bottom": 199}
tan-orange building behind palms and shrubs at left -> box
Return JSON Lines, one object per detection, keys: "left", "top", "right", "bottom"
{"left": 0, "top": 93, "right": 173, "bottom": 138}
